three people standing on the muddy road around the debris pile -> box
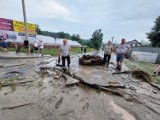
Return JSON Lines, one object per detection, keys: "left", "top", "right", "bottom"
{"left": 58, "top": 38, "right": 130, "bottom": 70}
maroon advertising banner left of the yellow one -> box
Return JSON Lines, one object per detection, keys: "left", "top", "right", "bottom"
{"left": 0, "top": 18, "right": 13, "bottom": 31}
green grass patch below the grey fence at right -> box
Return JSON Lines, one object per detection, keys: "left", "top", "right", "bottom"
{"left": 124, "top": 59, "right": 160, "bottom": 84}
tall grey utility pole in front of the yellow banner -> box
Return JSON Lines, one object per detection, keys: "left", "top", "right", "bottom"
{"left": 22, "top": 0, "right": 28, "bottom": 40}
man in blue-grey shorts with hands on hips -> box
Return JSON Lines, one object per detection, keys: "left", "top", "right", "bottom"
{"left": 114, "top": 38, "right": 130, "bottom": 71}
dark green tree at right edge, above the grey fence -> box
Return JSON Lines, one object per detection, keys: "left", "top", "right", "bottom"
{"left": 146, "top": 16, "right": 160, "bottom": 47}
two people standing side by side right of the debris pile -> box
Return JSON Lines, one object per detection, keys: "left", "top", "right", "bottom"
{"left": 103, "top": 38, "right": 130, "bottom": 71}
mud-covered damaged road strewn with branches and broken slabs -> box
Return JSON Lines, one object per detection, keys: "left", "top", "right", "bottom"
{"left": 0, "top": 55, "right": 160, "bottom": 120}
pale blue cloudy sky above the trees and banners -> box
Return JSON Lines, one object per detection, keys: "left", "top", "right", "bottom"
{"left": 0, "top": 0, "right": 160, "bottom": 43}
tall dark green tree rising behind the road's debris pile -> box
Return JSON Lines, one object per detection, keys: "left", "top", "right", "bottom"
{"left": 91, "top": 29, "right": 103, "bottom": 50}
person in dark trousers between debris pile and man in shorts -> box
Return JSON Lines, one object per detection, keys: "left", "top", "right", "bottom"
{"left": 103, "top": 40, "right": 113, "bottom": 67}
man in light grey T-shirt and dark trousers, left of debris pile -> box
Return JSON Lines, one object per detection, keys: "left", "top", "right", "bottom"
{"left": 59, "top": 39, "right": 71, "bottom": 68}
